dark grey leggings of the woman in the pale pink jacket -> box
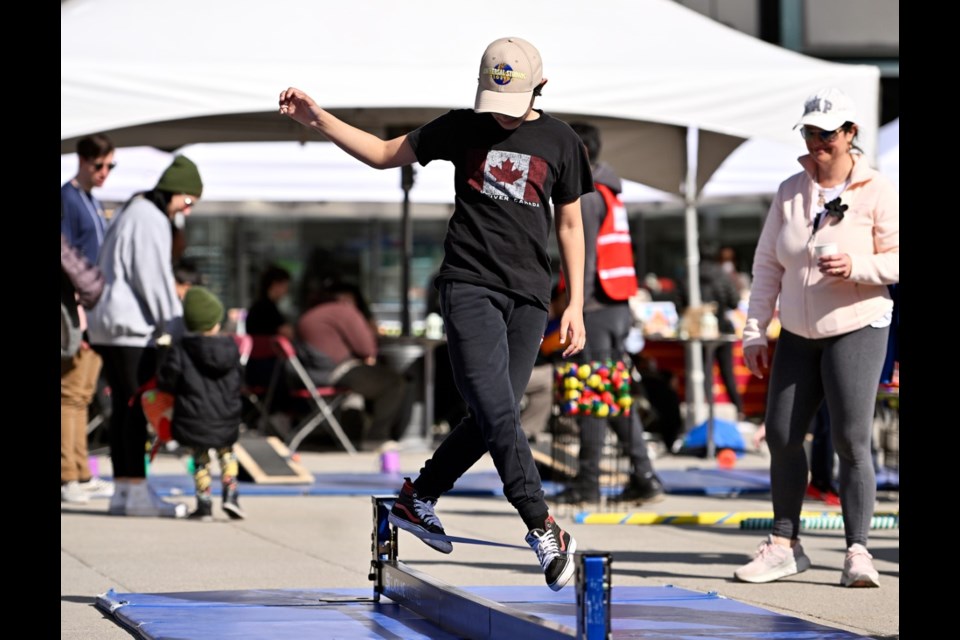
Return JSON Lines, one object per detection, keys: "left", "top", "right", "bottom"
{"left": 766, "top": 327, "right": 889, "bottom": 547}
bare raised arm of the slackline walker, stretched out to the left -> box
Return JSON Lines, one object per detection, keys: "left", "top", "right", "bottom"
{"left": 280, "top": 87, "right": 417, "bottom": 169}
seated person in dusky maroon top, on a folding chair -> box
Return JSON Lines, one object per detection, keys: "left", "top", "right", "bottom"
{"left": 297, "top": 285, "right": 413, "bottom": 449}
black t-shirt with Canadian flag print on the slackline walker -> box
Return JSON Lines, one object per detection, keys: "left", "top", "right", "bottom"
{"left": 407, "top": 109, "right": 593, "bottom": 309}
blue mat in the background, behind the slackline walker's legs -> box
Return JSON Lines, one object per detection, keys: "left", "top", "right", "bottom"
{"left": 144, "top": 468, "right": 900, "bottom": 497}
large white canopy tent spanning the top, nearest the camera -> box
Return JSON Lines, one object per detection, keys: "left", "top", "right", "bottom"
{"left": 60, "top": 0, "right": 879, "bottom": 424}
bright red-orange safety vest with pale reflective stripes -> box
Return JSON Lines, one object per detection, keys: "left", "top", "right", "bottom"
{"left": 594, "top": 182, "right": 637, "bottom": 300}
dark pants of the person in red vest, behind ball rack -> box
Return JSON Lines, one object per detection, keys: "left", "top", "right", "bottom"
{"left": 576, "top": 304, "right": 653, "bottom": 493}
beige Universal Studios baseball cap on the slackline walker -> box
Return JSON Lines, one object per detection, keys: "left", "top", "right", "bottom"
{"left": 473, "top": 38, "right": 543, "bottom": 118}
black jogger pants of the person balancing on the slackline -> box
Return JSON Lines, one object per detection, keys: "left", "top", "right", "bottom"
{"left": 414, "top": 282, "right": 548, "bottom": 528}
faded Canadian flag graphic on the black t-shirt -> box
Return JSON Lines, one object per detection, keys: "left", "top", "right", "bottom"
{"left": 469, "top": 151, "right": 547, "bottom": 206}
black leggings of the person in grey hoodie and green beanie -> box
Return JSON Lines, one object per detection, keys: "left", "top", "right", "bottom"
{"left": 94, "top": 345, "right": 157, "bottom": 478}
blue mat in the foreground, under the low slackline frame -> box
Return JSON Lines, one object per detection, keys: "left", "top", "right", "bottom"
{"left": 97, "top": 586, "right": 862, "bottom": 640}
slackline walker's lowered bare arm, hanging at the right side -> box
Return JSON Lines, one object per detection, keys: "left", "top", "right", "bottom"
{"left": 556, "top": 198, "right": 587, "bottom": 358}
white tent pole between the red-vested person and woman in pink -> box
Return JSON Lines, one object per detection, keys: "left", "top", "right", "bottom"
{"left": 684, "top": 127, "right": 705, "bottom": 431}
